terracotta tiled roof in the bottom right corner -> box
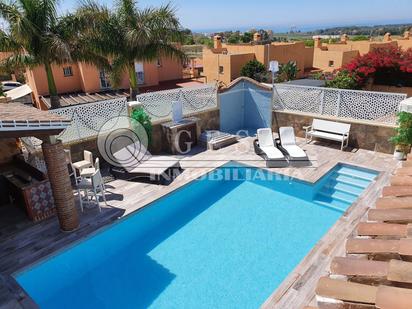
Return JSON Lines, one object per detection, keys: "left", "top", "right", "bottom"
{"left": 310, "top": 155, "right": 412, "bottom": 309}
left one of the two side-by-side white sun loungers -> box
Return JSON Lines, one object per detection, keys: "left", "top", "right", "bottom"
{"left": 253, "top": 128, "right": 288, "bottom": 167}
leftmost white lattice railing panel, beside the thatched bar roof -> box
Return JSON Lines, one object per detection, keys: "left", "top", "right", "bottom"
{"left": 50, "top": 98, "right": 127, "bottom": 143}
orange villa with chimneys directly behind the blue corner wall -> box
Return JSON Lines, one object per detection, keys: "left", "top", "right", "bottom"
{"left": 203, "top": 33, "right": 313, "bottom": 84}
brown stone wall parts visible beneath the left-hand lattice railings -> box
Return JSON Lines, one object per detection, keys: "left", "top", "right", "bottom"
{"left": 65, "top": 108, "right": 219, "bottom": 162}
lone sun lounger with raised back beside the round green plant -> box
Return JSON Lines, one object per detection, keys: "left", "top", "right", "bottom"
{"left": 111, "top": 143, "right": 181, "bottom": 183}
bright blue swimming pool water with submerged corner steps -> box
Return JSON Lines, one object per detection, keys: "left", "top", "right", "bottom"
{"left": 16, "top": 165, "right": 376, "bottom": 308}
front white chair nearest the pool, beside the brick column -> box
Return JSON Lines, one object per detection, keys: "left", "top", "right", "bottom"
{"left": 77, "top": 170, "right": 107, "bottom": 212}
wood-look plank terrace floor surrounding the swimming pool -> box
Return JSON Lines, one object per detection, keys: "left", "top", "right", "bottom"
{"left": 0, "top": 138, "right": 398, "bottom": 308}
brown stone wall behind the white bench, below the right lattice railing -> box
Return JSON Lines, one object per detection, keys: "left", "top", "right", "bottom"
{"left": 272, "top": 111, "right": 395, "bottom": 153}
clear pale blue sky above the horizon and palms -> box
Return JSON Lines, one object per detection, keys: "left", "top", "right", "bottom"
{"left": 60, "top": 0, "right": 412, "bottom": 32}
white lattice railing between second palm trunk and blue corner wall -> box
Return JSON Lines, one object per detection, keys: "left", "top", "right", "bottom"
{"left": 137, "top": 85, "right": 217, "bottom": 121}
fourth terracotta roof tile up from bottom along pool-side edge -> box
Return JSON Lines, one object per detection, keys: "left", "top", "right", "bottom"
{"left": 357, "top": 222, "right": 408, "bottom": 238}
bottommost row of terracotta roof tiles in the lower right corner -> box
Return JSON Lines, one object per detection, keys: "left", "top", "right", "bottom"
{"left": 316, "top": 277, "right": 412, "bottom": 309}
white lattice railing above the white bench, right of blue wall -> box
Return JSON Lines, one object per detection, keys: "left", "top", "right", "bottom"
{"left": 273, "top": 84, "right": 406, "bottom": 124}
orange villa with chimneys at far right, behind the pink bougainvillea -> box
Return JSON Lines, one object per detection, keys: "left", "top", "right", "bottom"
{"left": 313, "top": 31, "right": 412, "bottom": 72}
